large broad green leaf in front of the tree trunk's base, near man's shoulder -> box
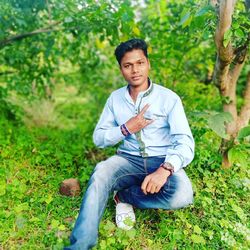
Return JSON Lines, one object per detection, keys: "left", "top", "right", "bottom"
{"left": 208, "top": 112, "right": 233, "bottom": 139}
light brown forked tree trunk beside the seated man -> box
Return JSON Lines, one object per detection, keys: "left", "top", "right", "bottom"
{"left": 214, "top": 0, "right": 250, "bottom": 167}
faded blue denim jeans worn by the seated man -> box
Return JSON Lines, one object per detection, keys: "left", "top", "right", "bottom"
{"left": 64, "top": 152, "right": 193, "bottom": 250}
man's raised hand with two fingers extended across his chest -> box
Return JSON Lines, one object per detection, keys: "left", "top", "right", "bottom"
{"left": 125, "top": 104, "right": 154, "bottom": 134}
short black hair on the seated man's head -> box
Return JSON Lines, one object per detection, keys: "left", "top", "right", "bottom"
{"left": 115, "top": 38, "right": 148, "bottom": 65}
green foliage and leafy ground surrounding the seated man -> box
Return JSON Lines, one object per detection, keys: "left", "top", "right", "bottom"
{"left": 0, "top": 0, "right": 250, "bottom": 250}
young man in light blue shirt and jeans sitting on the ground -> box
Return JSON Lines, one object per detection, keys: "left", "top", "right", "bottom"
{"left": 65, "top": 39, "right": 194, "bottom": 250}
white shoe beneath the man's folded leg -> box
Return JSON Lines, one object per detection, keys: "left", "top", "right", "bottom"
{"left": 115, "top": 202, "right": 135, "bottom": 230}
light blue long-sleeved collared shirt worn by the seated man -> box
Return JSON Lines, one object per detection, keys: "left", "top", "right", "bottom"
{"left": 93, "top": 82, "right": 194, "bottom": 172}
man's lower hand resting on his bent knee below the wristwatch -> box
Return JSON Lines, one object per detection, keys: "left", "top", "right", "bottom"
{"left": 141, "top": 167, "right": 171, "bottom": 194}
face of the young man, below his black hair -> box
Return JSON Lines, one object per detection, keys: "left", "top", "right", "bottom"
{"left": 120, "top": 49, "right": 150, "bottom": 89}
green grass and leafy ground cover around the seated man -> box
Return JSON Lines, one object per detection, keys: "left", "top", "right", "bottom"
{"left": 0, "top": 83, "right": 250, "bottom": 250}
